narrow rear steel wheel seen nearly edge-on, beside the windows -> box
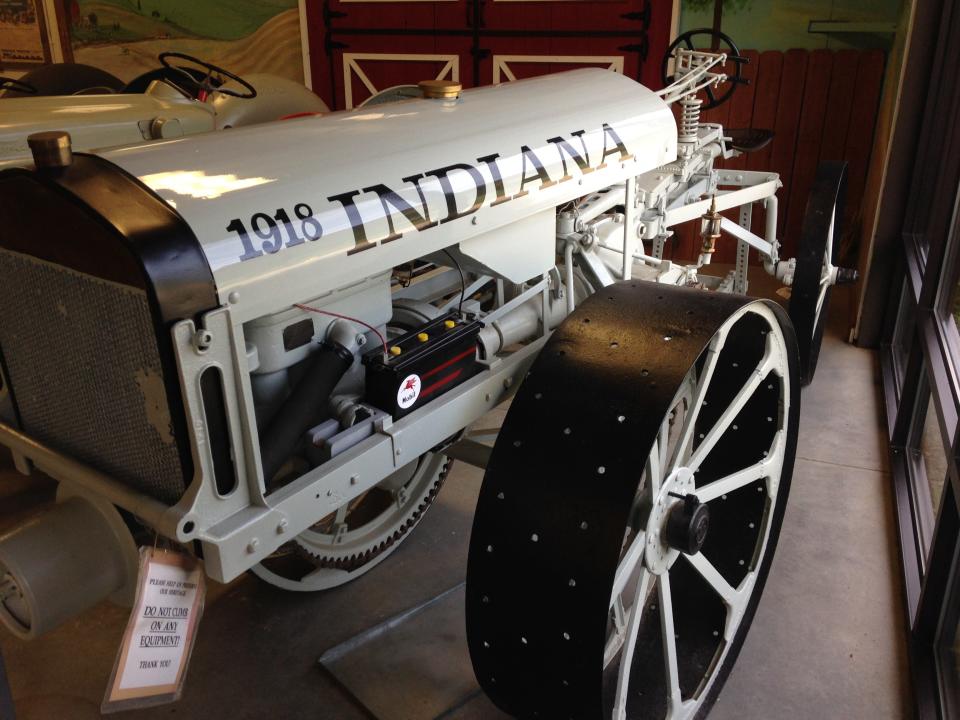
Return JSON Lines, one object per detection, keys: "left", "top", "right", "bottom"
{"left": 790, "top": 162, "right": 856, "bottom": 385}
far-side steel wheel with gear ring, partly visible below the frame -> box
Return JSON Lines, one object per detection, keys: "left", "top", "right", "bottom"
{"left": 253, "top": 453, "right": 451, "bottom": 592}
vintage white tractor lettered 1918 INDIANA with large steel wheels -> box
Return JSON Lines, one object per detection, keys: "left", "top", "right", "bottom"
{"left": 0, "top": 32, "right": 849, "bottom": 720}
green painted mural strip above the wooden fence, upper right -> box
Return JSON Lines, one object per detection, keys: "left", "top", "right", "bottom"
{"left": 680, "top": 0, "right": 903, "bottom": 51}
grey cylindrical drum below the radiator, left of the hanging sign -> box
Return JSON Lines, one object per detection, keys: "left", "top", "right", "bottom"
{"left": 0, "top": 492, "right": 139, "bottom": 639}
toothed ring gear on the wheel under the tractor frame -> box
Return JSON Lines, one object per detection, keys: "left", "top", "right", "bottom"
{"left": 294, "top": 453, "right": 452, "bottom": 572}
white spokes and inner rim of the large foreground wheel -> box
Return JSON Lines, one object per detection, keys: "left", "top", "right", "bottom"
{"left": 604, "top": 304, "right": 791, "bottom": 720}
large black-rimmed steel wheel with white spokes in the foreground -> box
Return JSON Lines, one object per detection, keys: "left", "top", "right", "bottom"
{"left": 467, "top": 283, "right": 799, "bottom": 720}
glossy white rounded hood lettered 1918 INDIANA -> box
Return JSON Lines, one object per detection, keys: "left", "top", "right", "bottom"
{"left": 104, "top": 70, "right": 676, "bottom": 321}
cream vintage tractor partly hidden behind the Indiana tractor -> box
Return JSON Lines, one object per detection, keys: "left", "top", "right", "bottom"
{"left": 0, "top": 52, "right": 329, "bottom": 167}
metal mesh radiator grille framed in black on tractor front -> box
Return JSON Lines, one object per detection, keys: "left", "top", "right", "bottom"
{"left": 0, "top": 248, "right": 184, "bottom": 503}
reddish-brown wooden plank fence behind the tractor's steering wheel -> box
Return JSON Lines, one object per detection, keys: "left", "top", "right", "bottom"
{"left": 666, "top": 50, "right": 885, "bottom": 263}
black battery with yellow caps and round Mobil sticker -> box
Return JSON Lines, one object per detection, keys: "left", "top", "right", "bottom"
{"left": 363, "top": 310, "right": 483, "bottom": 419}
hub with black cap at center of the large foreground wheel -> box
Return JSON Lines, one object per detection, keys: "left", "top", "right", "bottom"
{"left": 643, "top": 467, "right": 709, "bottom": 575}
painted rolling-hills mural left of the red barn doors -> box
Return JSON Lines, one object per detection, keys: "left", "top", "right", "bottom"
{"left": 67, "top": 0, "right": 303, "bottom": 82}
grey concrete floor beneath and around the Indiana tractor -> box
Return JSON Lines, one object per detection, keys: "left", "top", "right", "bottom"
{"left": 0, "top": 284, "right": 912, "bottom": 720}
